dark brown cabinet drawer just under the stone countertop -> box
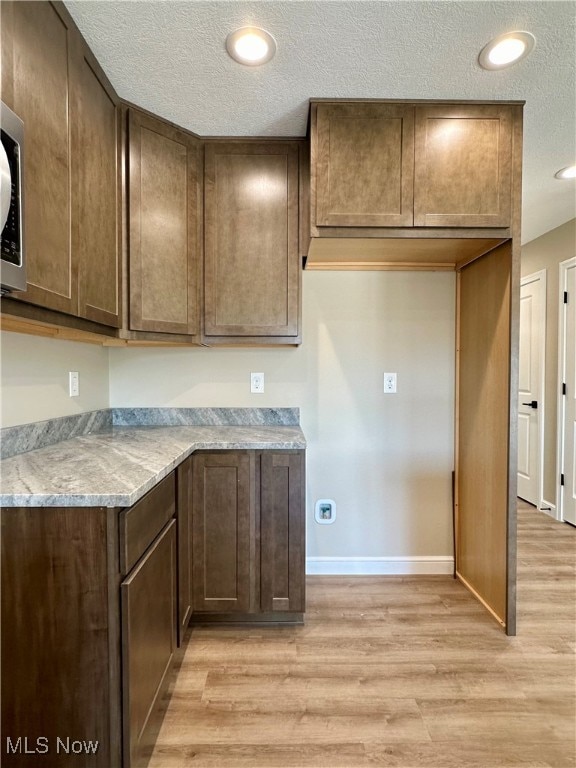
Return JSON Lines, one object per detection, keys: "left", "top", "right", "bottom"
{"left": 120, "top": 472, "right": 176, "bottom": 574}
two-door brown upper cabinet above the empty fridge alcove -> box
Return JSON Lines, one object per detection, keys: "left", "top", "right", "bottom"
{"left": 311, "top": 102, "right": 513, "bottom": 237}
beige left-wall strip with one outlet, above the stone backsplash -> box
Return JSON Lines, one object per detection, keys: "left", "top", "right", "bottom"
{"left": 0, "top": 331, "right": 110, "bottom": 427}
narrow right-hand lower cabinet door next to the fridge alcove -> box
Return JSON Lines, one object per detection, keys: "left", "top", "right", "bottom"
{"left": 260, "top": 451, "right": 305, "bottom": 612}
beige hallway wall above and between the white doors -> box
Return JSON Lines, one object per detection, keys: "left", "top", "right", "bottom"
{"left": 522, "top": 219, "right": 576, "bottom": 505}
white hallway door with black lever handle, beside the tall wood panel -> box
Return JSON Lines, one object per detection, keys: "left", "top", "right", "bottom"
{"left": 518, "top": 271, "right": 546, "bottom": 506}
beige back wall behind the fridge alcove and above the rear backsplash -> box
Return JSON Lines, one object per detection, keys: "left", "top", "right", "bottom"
{"left": 110, "top": 272, "right": 455, "bottom": 558}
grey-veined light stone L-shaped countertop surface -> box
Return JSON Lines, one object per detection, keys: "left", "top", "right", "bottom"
{"left": 0, "top": 426, "right": 306, "bottom": 507}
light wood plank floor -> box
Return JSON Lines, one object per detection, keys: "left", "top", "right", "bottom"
{"left": 149, "top": 502, "right": 576, "bottom": 768}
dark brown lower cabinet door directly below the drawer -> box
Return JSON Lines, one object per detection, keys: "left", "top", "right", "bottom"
{"left": 121, "top": 520, "right": 176, "bottom": 768}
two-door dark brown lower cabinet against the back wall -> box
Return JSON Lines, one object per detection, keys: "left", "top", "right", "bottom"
{"left": 192, "top": 450, "right": 305, "bottom": 621}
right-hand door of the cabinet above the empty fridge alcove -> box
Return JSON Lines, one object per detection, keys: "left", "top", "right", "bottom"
{"left": 414, "top": 105, "right": 512, "bottom": 227}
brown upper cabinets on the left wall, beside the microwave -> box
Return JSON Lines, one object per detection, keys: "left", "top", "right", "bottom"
{"left": 2, "top": 2, "right": 120, "bottom": 327}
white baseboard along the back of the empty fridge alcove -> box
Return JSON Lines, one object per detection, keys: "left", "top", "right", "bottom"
{"left": 306, "top": 555, "right": 454, "bottom": 576}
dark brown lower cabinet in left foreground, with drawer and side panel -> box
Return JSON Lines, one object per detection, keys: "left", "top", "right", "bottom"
{"left": 0, "top": 473, "right": 177, "bottom": 768}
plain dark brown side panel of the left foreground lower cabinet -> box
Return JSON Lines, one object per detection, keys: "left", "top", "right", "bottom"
{"left": 0, "top": 507, "right": 122, "bottom": 768}
